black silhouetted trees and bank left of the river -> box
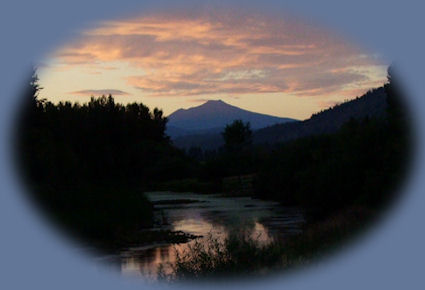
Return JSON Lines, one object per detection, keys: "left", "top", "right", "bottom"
{"left": 17, "top": 74, "right": 197, "bottom": 250}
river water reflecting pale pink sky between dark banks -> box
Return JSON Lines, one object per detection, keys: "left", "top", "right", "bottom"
{"left": 111, "top": 192, "right": 304, "bottom": 278}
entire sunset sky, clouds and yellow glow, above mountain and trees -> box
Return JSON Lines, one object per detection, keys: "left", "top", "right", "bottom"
{"left": 38, "top": 9, "right": 388, "bottom": 119}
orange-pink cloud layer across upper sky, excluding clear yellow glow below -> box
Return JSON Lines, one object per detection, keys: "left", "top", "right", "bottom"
{"left": 51, "top": 12, "right": 384, "bottom": 96}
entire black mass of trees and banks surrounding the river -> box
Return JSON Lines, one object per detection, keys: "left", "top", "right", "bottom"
{"left": 17, "top": 65, "right": 410, "bottom": 280}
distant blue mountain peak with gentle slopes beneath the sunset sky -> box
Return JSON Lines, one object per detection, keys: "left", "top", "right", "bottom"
{"left": 166, "top": 100, "right": 295, "bottom": 138}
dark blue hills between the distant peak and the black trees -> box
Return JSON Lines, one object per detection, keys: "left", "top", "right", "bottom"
{"left": 173, "top": 87, "right": 387, "bottom": 150}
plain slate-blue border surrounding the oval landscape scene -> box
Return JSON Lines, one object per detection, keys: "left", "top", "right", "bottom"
{"left": 0, "top": 0, "right": 425, "bottom": 290}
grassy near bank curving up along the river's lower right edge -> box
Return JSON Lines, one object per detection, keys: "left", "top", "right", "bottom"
{"left": 158, "top": 208, "right": 371, "bottom": 282}
